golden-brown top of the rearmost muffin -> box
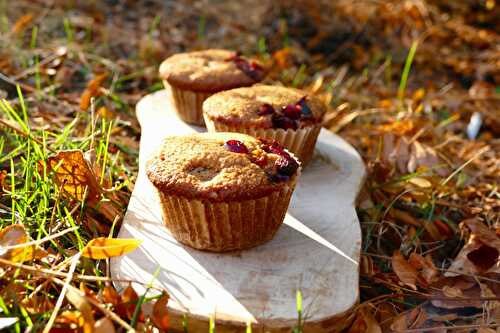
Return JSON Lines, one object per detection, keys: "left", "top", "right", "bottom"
{"left": 160, "top": 49, "right": 265, "bottom": 93}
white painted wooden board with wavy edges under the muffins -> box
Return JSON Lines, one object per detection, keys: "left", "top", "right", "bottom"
{"left": 111, "top": 91, "right": 365, "bottom": 332}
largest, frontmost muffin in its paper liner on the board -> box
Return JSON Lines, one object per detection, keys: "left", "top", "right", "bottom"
{"left": 146, "top": 133, "right": 300, "bottom": 252}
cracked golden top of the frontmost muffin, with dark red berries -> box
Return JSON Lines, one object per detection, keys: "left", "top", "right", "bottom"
{"left": 146, "top": 133, "right": 300, "bottom": 202}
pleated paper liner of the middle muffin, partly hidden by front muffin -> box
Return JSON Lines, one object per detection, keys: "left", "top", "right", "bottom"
{"left": 204, "top": 116, "right": 321, "bottom": 166}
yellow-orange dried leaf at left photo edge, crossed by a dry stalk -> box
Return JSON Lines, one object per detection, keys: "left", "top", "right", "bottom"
{"left": 0, "top": 224, "right": 47, "bottom": 263}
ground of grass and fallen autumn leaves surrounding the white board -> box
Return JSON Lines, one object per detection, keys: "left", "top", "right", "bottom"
{"left": 0, "top": 0, "right": 500, "bottom": 332}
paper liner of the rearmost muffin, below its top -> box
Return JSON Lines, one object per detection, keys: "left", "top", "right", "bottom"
{"left": 163, "top": 80, "right": 212, "bottom": 126}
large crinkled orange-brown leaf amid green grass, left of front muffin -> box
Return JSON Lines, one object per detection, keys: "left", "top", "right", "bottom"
{"left": 47, "top": 150, "right": 101, "bottom": 201}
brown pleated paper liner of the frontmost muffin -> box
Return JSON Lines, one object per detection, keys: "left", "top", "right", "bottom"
{"left": 158, "top": 176, "right": 300, "bottom": 252}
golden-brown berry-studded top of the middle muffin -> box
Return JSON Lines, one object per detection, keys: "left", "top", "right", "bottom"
{"left": 203, "top": 84, "right": 326, "bottom": 129}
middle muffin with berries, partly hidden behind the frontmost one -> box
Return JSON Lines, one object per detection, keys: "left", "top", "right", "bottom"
{"left": 203, "top": 85, "right": 326, "bottom": 165}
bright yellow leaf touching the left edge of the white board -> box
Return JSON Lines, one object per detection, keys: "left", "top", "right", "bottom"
{"left": 82, "top": 237, "right": 142, "bottom": 259}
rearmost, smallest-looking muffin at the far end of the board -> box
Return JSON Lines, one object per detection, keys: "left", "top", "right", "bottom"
{"left": 159, "top": 49, "right": 265, "bottom": 125}
